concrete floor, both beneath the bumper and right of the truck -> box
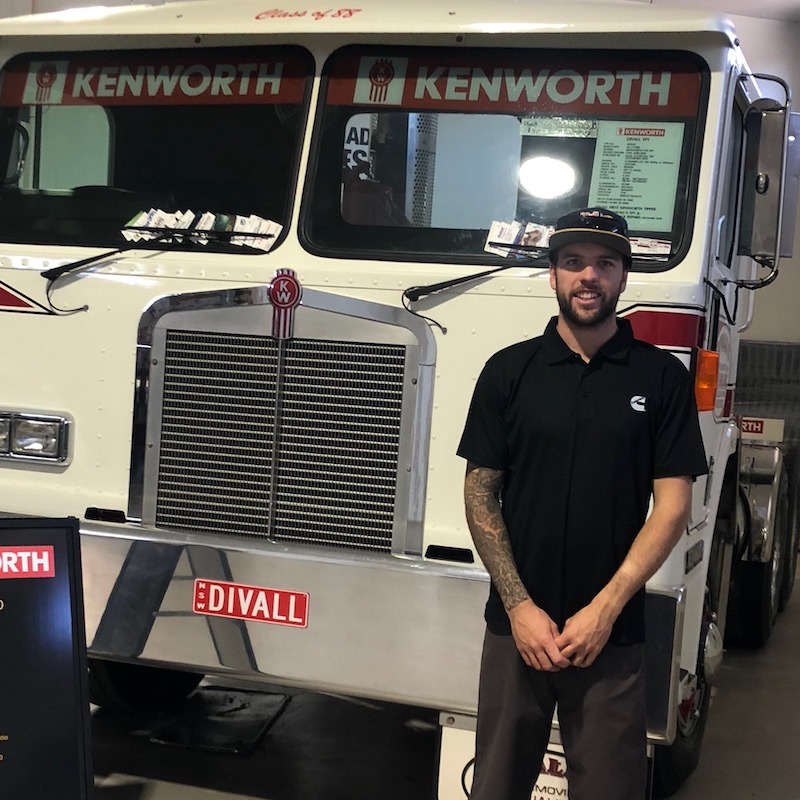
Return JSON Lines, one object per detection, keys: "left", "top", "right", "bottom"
{"left": 92, "top": 584, "right": 800, "bottom": 800}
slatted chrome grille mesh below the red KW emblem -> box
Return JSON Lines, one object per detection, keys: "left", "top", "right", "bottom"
{"left": 156, "top": 331, "right": 405, "bottom": 551}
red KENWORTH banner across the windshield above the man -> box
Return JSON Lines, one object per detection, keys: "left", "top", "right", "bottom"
{"left": 327, "top": 48, "right": 702, "bottom": 116}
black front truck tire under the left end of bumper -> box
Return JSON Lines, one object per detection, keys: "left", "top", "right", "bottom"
{"left": 89, "top": 658, "right": 203, "bottom": 713}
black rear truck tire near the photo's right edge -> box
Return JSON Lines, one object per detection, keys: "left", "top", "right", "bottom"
{"left": 725, "top": 470, "right": 789, "bottom": 648}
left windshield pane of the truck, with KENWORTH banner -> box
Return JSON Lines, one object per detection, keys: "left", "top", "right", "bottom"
{"left": 0, "top": 47, "right": 313, "bottom": 249}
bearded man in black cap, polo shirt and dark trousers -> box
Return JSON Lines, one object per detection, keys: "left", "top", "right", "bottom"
{"left": 458, "top": 208, "right": 707, "bottom": 800}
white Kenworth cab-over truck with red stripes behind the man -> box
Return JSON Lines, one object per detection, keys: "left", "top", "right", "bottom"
{"left": 0, "top": 0, "right": 797, "bottom": 800}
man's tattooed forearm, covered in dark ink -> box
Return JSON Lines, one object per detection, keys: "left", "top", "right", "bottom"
{"left": 464, "top": 463, "right": 528, "bottom": 610}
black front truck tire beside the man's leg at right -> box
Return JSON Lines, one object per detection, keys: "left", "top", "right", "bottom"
{"left": 653, "top": 675, "right": 711, "bottom": 798}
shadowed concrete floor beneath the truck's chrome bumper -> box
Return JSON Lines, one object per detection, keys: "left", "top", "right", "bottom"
{"left": 92, "top": 689, "right": 438, "bottom": 800}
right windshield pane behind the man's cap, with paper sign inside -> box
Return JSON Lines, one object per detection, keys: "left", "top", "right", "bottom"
{"left": 305, "top": 48, "right": 708, "bottom": 269}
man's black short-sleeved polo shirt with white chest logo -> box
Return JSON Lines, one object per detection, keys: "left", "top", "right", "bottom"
{"left": 458, "top": 317, "right": 707, "bottom": 644}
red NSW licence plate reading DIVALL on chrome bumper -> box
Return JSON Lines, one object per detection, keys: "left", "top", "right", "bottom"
{"left": 193, "top": 578, "right": 308, "bottom": 628}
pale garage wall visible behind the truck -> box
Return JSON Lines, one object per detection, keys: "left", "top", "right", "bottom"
{"left": 0, "top": 0, "right": 800, "bottom": 343}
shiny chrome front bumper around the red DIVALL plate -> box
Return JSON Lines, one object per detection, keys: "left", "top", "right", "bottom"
{"left": 81, "top": 522, "right": 488, "bottom": 713}
